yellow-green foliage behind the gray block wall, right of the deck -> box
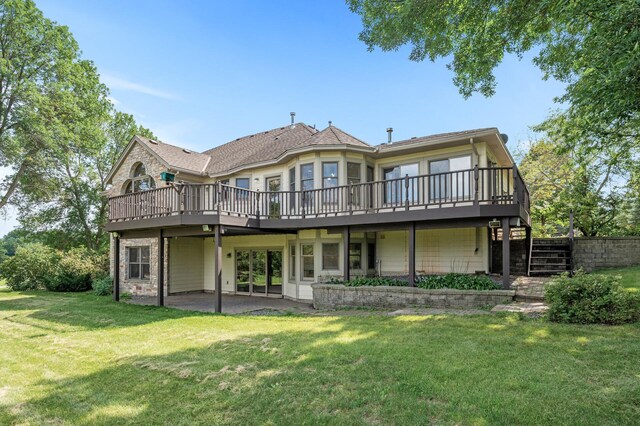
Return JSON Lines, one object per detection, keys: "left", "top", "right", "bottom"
{"left": 520, "top": 140, "right": 634, "bottom": 237}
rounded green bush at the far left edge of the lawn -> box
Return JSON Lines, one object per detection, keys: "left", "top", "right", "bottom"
{"left": 0, "top": 243, "right": 60, "bottom": 291}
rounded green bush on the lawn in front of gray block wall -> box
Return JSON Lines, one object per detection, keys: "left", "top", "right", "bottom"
{"left": 545, "top": 271, "right": 640, "bottom": 324}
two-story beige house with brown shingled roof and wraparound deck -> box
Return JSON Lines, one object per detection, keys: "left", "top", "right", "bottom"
{"left": 106, "top": 120, "right": 531, "bottom": 309}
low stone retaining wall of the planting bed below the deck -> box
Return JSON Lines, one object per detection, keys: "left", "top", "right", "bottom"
{"left": 311, "top": 284, "right": 516, "bottom": 309}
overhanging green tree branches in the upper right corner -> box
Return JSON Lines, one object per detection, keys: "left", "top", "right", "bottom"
{"left": 347, "top": 0, "right": 640, "bottom": 153}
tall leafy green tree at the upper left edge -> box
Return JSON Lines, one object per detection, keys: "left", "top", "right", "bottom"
{"left": 0, "top": 0, "right": 106, "bottom": 208}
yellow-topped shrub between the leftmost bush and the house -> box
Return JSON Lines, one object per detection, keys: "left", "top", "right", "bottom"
{"left": 45, "top": 248, "right": 102, "bottom": 292}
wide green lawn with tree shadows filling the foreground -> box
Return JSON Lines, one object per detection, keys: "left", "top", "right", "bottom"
{"left": 0, "top": 291, "right": 640, "bottom": 425}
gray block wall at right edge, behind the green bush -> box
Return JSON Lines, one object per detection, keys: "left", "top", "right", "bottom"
{"left": 573, "top": 237, "right": 640, "bottom": 271}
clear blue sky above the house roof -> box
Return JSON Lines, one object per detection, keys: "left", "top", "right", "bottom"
{"left": 0, "top": 0, "right": 563, "bottom": 234}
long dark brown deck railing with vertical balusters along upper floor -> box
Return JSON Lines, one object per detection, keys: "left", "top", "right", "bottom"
{"left": 109, "top": 167, "right": 529, "bottom": 222}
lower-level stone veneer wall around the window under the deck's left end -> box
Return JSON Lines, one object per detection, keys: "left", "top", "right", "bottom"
{"left": 110, "top": 238, "right": 171, "bottom": 296}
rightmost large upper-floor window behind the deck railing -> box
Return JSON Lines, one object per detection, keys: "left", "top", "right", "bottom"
{"left": 429, "top": 155, "right": 473, "bottom": 201}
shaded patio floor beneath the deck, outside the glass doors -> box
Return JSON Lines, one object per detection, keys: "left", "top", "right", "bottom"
{"left": 128, "top": 293, "right": 314, "bottom": 314}
